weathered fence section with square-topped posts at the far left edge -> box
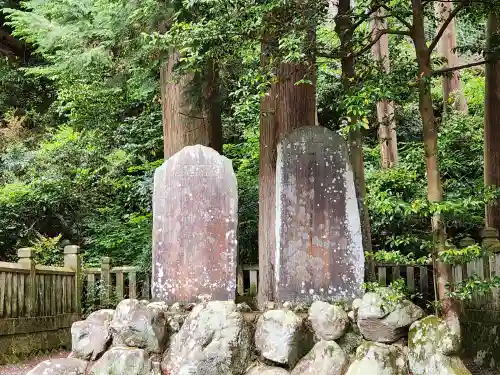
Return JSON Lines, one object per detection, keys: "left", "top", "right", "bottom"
{"left": 0, "top": 246, "right": 81, "bottom": 364}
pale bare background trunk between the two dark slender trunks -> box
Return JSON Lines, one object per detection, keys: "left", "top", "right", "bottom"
{"left": 372, "top": 9, "right": 398, "bottom": 169}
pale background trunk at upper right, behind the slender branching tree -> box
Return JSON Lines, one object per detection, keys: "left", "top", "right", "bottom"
{"left": 435, "top": 1, "right": 468, "bottom": 114}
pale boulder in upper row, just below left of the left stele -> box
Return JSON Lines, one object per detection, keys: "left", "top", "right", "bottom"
{"left": 110, "top": 299, "right": 168, "bottom": 353}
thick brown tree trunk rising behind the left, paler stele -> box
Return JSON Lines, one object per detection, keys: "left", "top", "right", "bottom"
{"left": 160, "top": 53, "right": 222, "bottom": 160}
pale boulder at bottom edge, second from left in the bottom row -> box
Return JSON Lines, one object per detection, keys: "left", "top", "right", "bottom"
{"left": 90, "top": 347, "right": 152, "bottom": 375}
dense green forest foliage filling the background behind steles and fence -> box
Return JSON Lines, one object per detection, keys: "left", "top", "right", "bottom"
{"left": 0, "top": 0, "right": 496, "bottom": 276}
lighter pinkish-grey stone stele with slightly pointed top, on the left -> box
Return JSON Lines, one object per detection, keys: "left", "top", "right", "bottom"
{"left": 152, "top": 145, "right": 238, "bottom": 303}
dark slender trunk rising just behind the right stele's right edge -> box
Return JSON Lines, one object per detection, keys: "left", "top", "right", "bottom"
{"left": 336, "top": 0, "right": 375, "bottom": 279}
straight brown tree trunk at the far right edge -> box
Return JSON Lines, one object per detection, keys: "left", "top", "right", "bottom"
{"left": 484, "top": 13, "right": 500, "bottom": 229}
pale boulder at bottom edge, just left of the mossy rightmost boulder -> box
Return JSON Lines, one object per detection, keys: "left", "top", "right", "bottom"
{"left": 346, "top": 341, "right": 409, "bottom": 375}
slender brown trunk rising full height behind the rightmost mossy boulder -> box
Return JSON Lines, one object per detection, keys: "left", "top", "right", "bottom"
{"left": 412, "top": 0, "right": 460, "bottom": 330}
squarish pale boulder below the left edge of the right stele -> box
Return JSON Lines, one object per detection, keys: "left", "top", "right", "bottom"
{"left": 255, "top": 309, "right": 305, "bottom": 367}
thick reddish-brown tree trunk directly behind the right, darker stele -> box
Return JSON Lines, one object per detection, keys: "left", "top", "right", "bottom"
{"left": 258, "top": 43, "right": 316, "bottom": 307}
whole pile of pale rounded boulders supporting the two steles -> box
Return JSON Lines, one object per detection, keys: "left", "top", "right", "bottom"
{"left": 27, "top": 288, "right": 470, "bottom": 375}
